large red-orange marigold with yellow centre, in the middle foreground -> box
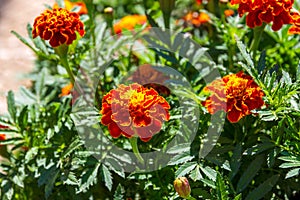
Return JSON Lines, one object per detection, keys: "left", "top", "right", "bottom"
{"left": 100, "top": 83, "right": 170, "bottom": 142}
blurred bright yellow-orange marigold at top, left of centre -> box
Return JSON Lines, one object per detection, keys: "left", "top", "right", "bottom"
{"left": 114, "top": 14, "right": 147, "bottom": 34}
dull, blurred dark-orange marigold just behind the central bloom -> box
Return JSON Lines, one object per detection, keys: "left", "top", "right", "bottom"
{"left": 128, "top": 64, "right": 170, "bottom": 96}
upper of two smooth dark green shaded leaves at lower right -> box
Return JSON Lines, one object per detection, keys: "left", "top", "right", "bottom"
{"left": 236, "top": 155, "right": 264, "bottom": 193}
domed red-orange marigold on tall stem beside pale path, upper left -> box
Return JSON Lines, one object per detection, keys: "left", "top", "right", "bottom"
{"left": 32, "top": 8, "right": 85, "bottom": 47}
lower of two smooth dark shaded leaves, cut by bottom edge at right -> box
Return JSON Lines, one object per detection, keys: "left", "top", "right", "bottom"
{"left": 246, "top": 175, "right": 280, "bottom": 200}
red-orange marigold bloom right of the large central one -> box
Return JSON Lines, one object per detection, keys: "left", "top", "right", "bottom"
{"left": 202, "top": 72, "right": 264, "bottom": 123}
